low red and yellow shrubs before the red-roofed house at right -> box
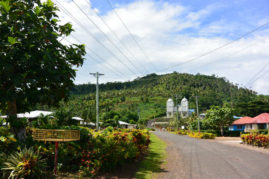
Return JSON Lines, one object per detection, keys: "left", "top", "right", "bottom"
{"left": 241, "top": 133, "right": 269, "bottom": 148}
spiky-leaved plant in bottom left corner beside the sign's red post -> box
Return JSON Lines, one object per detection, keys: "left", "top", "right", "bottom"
{"left": 2, "top": 147, "right": 46, "bottom": 179}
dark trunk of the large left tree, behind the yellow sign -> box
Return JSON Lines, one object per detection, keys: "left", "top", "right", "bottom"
{"left": 7, "top": 99, "right": 26, "bottom": 140}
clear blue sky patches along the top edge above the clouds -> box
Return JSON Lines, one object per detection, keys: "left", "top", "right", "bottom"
{"left": 91, "top": 0, "right": 269, "bottom": 39}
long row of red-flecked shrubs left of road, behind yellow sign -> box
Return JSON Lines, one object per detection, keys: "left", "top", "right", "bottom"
{"left": 0, "top": 126, "right": 150, "bottom": 177}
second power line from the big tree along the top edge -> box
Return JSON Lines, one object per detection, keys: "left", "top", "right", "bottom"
{"left": 72, "top": 0, "right": 143, "bottom": 74}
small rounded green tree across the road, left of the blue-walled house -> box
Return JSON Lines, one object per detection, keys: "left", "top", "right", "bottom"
{"left": 206, "top": 106, "right": 234, "bottom": 136}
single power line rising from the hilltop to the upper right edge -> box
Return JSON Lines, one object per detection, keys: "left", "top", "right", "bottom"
{"left": 158, "top": 22, "right": 269, "bottom": 72}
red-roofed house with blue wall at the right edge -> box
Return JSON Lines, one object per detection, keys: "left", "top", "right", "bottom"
{"left": 229, "top": 113, "right": 269, "bottom": 132}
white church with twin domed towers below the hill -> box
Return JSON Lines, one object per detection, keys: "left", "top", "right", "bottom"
{"left": 166, "top": 97, "right": 189, "bottom": 118}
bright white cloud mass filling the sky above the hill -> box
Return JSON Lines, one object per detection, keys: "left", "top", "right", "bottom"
{"left": 51, "top": 0, "right": 269, "bottom": 94}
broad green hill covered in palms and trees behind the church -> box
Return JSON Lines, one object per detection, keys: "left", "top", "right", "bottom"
{"left": 65, "top": 72, "right": 269, "bottom": 122}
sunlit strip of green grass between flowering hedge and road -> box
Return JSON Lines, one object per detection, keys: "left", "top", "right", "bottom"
{"left": 135, "top": 133, "right": 166, "bottom": 179}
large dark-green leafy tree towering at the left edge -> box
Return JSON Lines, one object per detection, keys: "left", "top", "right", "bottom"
{"left": 0, "top": 0, "right": 85, "bottom": 137}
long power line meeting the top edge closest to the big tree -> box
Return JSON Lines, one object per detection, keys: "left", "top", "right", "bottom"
{"left": 55, "top": 0, "right": 136, "bottom": 76}
